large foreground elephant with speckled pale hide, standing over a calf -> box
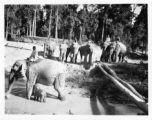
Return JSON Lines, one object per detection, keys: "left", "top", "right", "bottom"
{"left": 5, "top": 59, "right": 67, "bottom": 100}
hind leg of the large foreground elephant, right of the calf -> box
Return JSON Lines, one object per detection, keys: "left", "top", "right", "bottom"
{"left": 54, "top": 74, "right": 65, "bottom": 101}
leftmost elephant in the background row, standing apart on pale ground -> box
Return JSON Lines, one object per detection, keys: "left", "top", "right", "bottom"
{"left": 44, "top": 40, "right": 57, "bottom": 58}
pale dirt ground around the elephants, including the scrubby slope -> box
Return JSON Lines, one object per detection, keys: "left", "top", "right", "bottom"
{"left": 4, "top": 41, "right": 147, "bottom": 115}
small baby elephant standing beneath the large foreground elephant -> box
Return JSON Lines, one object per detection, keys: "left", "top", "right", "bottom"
{"left": 33, "top": 83, "right": 46, "bottom": 102}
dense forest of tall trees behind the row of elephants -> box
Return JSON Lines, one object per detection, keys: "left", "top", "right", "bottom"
{"left": 4, "top": 4, "right": 148, "bottom": 52}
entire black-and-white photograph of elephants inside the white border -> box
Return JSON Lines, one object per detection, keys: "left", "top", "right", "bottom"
{"left": 1, "top": 1, "right": 151, "bottom": 116}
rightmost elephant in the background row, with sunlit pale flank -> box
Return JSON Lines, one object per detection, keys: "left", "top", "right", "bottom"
{"left": 108, "top": 42, "right": 127, "bottom": 62}
